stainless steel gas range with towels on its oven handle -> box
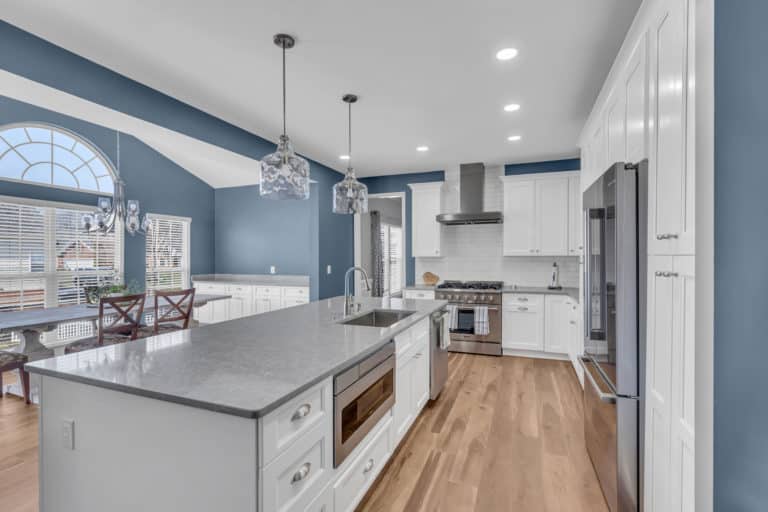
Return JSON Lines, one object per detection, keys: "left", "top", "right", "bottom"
{"left": 435, "top": 281, "right": 504, "bottom": 356}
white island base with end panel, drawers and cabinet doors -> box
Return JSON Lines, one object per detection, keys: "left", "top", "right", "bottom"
{"left": 40, "top": 319, "right": 429, "bottom": 512}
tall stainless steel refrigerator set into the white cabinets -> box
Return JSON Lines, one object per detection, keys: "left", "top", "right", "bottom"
{"left": 580, "top": 160, "right": 648, "bottom": 512}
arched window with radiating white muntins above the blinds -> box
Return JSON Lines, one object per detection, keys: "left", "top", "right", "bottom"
{"left": 0, "top": 123, "right": 115, "bottom": 195}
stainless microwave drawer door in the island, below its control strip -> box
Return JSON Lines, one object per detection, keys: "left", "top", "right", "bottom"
{"left": 333, "top": 356, "right": 395, "bottom": 467}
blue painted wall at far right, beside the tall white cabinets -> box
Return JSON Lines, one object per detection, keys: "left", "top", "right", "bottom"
{"left": 714, "top": 0, "right": 768, "bottom": 511}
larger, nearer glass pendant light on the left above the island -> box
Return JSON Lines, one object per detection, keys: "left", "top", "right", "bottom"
{"left": 259, "top": 34, "right": 309, "bottom": 199}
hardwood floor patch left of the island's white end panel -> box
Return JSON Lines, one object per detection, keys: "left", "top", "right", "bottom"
{"left": 0, "top": 374, "right": 38, "bottom": 512}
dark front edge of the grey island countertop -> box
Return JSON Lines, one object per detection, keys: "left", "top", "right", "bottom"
{"left": 24, "top": 301, "right": 447, "bottom": 419}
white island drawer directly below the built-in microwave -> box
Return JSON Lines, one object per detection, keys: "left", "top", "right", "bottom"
{"left": 333, "top": 417, "right": 392, "bottom": 512}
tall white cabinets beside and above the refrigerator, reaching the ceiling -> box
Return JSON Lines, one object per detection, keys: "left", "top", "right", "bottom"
{"left": 581, "top": 0, "right": 696, "bottom": 512}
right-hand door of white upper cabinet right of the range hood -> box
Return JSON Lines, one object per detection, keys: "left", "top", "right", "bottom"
{"left": 536, "top": 178, "right": 568, "bottom": 256}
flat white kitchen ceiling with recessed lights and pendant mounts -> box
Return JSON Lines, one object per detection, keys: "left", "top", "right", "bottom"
{"left": 2, "top": 0, "right": 641, "bottom": 179}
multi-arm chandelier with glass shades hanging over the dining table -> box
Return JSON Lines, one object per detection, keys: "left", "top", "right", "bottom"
{"left": 82, "top": 132, "right": 151, "bottom": 235}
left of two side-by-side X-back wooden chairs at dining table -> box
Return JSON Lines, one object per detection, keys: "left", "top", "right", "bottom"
{"left": 64, "top": 293, "right": 146, "bottom": 354}
